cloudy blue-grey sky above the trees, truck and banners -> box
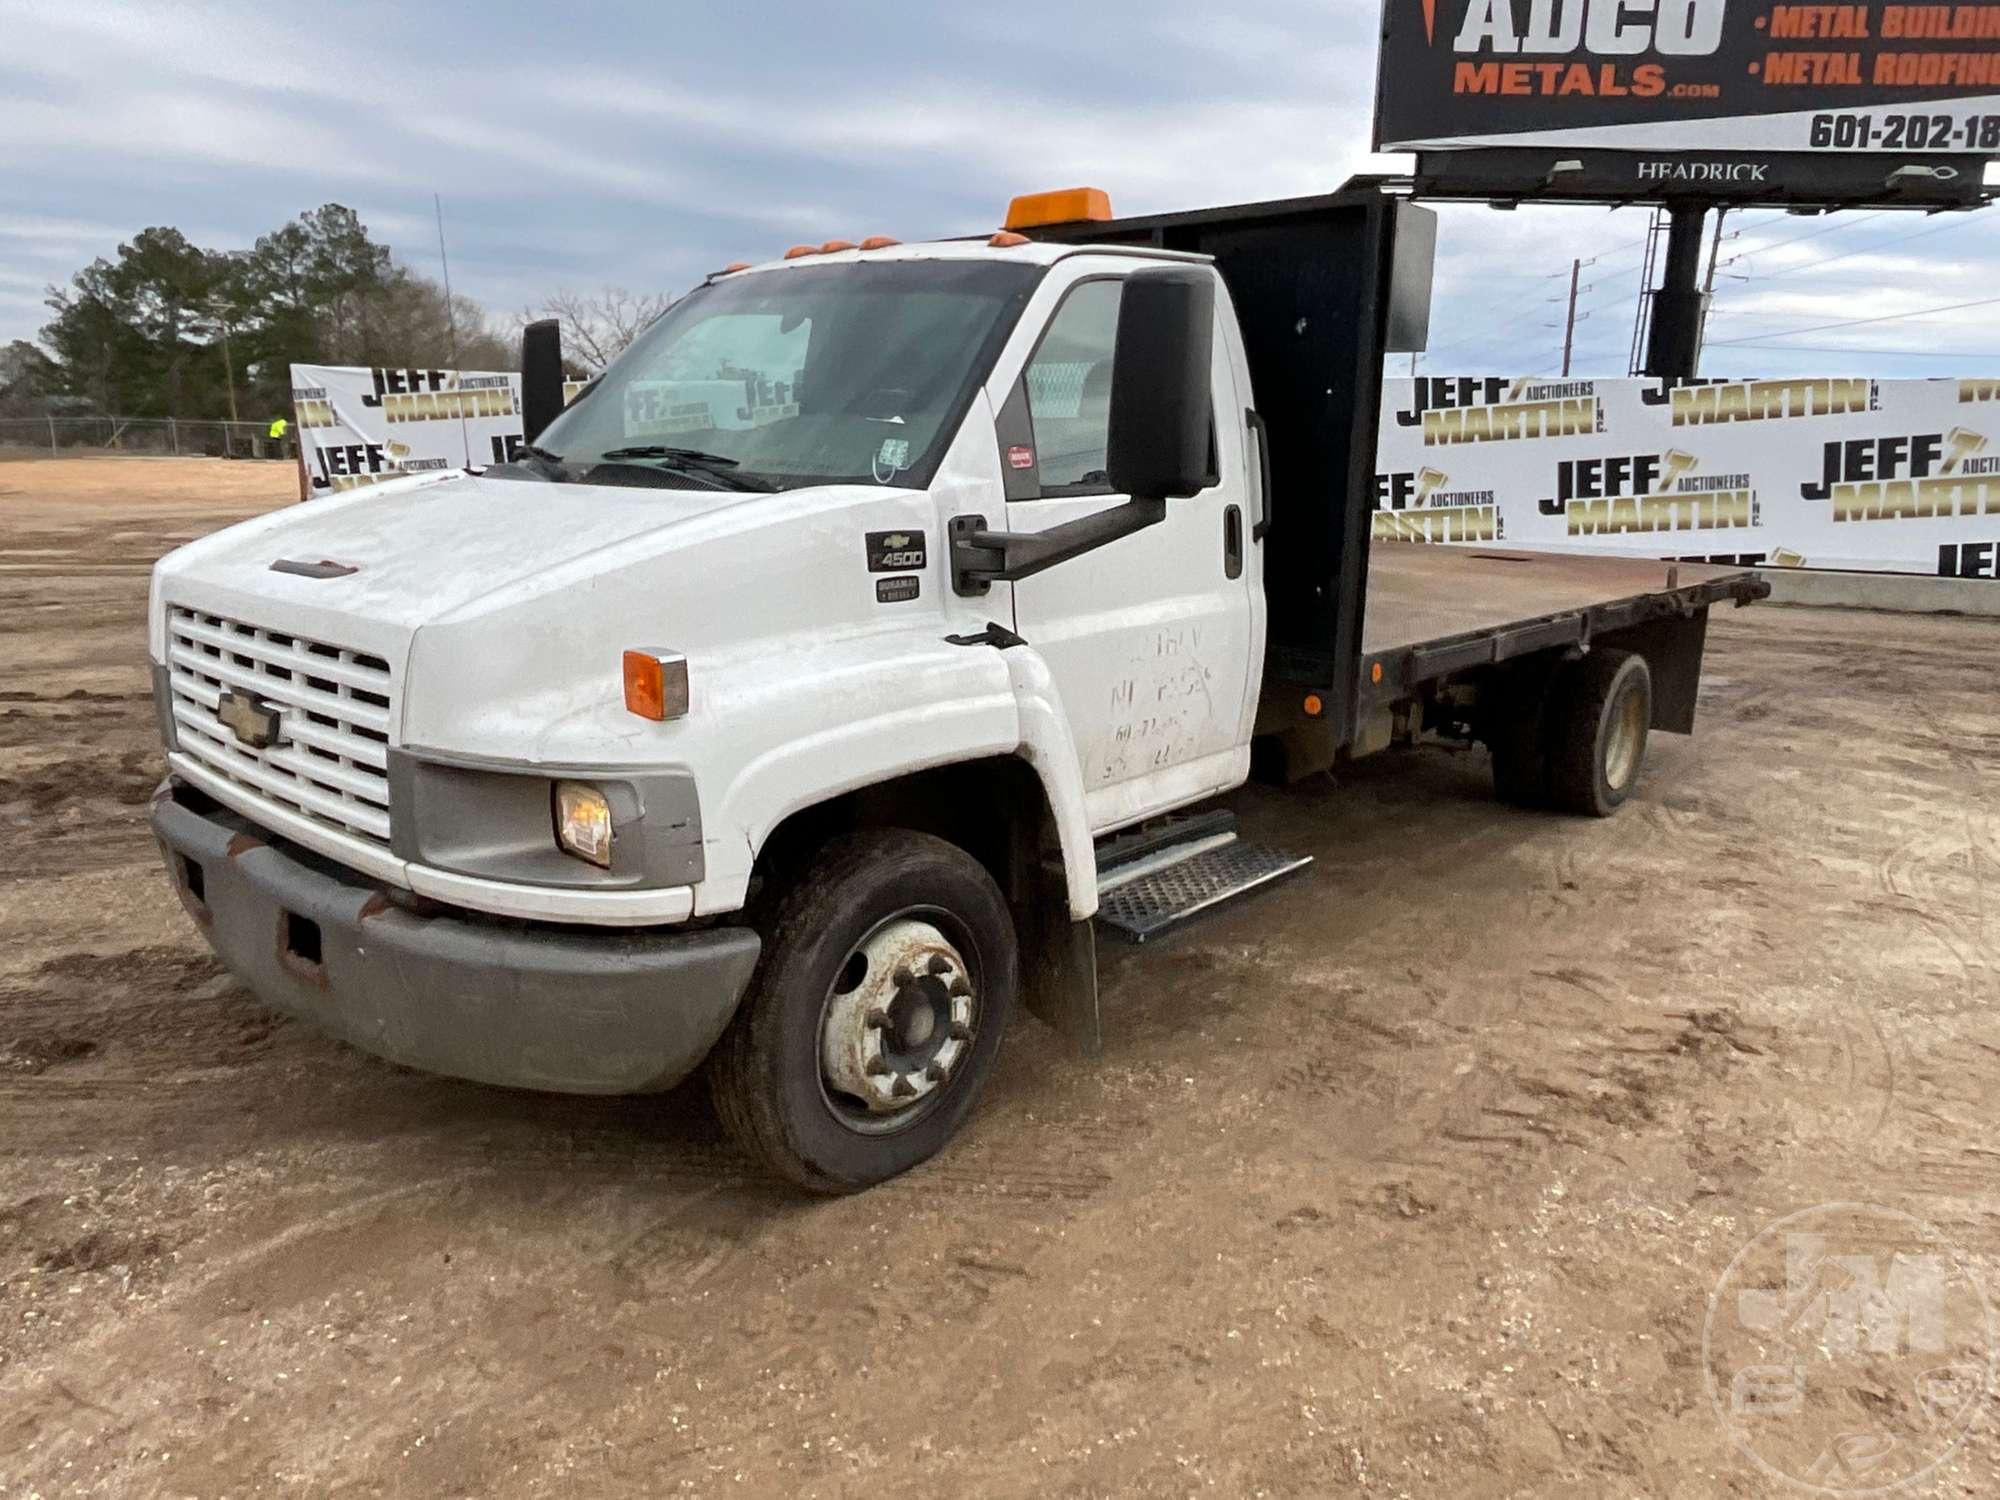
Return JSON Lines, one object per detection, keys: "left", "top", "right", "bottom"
{"left": 0, "top": 0, "right": 2000, "bottom": 376}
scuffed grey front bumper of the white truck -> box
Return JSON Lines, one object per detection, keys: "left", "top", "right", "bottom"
{"left": 152, "top": 780, "right": 760, "bottom": 1094}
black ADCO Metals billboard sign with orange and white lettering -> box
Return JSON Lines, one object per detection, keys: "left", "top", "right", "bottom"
{"left": 1374, "top": 0, "right": 2000, "bottom": 162}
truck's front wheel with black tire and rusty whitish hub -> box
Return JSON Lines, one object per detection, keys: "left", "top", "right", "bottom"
{"left": 710, "top": 828, "right": 1020, "bottom": 1194}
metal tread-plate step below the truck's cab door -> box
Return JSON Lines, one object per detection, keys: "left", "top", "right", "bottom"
{"left": 1098, "top": 812, "right": 1312, "bottom": 942}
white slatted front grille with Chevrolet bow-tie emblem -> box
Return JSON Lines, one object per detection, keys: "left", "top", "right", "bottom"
{"left": 166, "top": 606, "right": 394, "bottom": 846}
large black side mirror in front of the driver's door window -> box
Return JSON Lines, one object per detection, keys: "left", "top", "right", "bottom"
{"left": 1104, "top": 266, "right": 1216, "bottom": 500}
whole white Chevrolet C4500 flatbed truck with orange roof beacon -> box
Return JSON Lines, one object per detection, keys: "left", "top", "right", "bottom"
{"left": 150, "top": 180, "right": 1764, "bottom": 1192}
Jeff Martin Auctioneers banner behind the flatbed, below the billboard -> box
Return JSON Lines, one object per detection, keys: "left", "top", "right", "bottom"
{"left": 1374, "top": 376, "right": 2000, "bottom": 578}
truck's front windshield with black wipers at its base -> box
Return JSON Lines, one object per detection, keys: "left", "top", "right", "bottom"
{"left": 536, "top": 260, "right": 1042, "bottom": 490}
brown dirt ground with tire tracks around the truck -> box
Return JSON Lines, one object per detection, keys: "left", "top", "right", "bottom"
{"left": 0, "top": 460, "right": 2000, "bottom": 1500}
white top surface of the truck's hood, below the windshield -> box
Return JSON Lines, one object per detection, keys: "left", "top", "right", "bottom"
{"left": 160, "top": 474, "right": 770, "bottom": 636}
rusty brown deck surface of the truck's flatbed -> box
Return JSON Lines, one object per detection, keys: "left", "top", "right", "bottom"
{"left": 1362, "top": 542, "right": 1744, "bottom": 658}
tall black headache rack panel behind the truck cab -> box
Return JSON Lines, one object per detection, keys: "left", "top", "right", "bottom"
{"left": 1032, "top": 178, "right": 1436, "bottom": 756}
